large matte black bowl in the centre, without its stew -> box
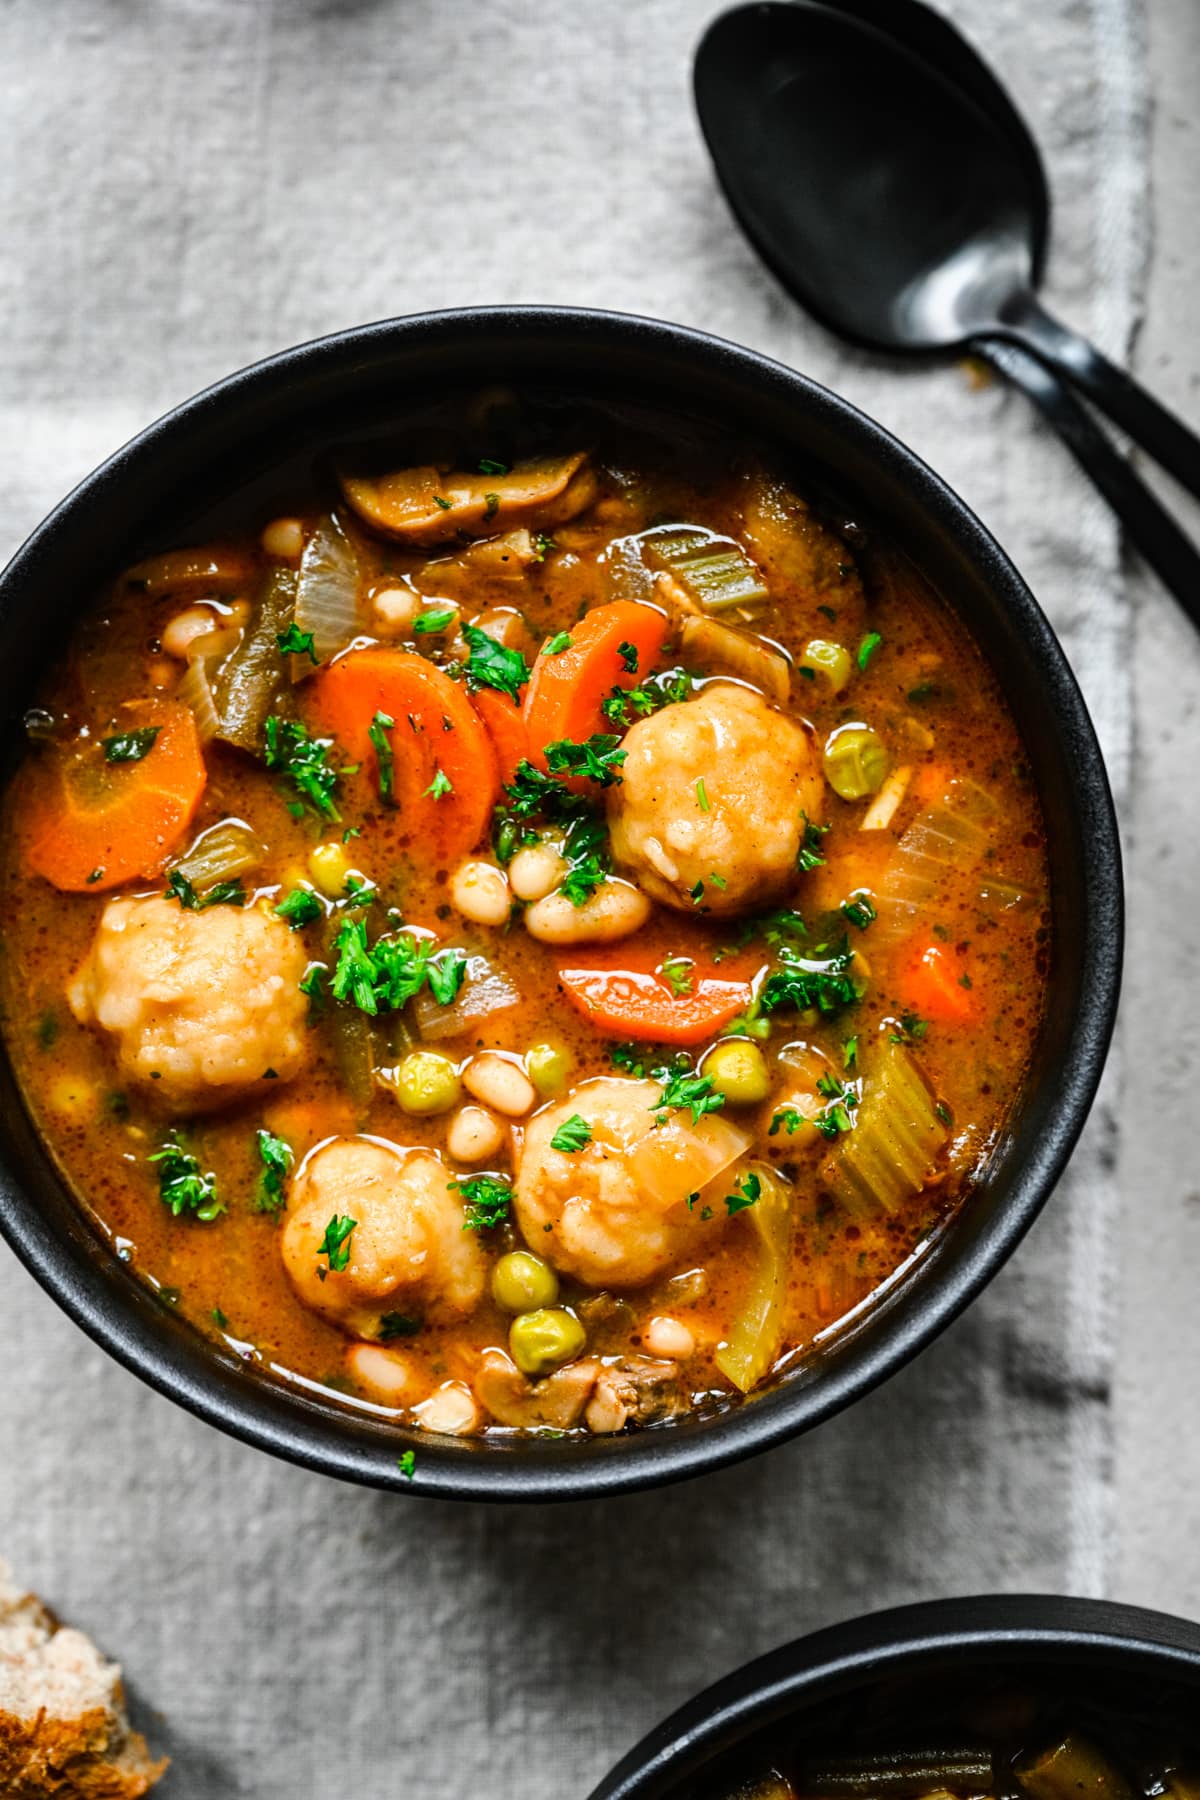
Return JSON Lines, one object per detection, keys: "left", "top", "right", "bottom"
{"left": 0, "top": 308, "right": 1123, "bottom": 1499}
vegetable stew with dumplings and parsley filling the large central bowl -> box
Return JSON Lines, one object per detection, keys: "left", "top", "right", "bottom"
{"left": 4, "top": 396, "right": 1051, "bottom": 1435}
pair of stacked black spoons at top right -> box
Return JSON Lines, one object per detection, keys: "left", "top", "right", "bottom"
{"left": 696, "top": 0, "right": 1200, "bottom": 625}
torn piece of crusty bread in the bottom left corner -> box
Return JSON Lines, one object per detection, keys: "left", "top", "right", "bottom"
{"left": 0, "top": 1561, "right": 166, "bottom": 1800}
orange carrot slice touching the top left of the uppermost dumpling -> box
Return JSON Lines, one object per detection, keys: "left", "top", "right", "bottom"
{"left": 525, "top": 599, "right": 667, "bottom": 767}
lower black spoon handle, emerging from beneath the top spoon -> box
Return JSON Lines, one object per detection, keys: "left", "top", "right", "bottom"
{"left": 986, "top": 342, "right": 1200, "bottom": 628}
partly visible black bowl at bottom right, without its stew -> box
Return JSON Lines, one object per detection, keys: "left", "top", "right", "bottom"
{"left": 590, "top": 1595, "right": 1200, "bottom": 1800}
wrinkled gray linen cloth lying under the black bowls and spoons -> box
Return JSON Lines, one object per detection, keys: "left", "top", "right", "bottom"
{"left": 0, "top": 0, "right": 1165, "bottom": 1800}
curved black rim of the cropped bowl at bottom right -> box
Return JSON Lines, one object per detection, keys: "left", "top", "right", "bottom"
{"left": 590, "top": 1593, "right": 1200, "bottom": 1800}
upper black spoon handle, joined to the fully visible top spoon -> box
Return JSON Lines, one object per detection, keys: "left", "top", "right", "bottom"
{"left": 1000, "top": 292, "right": 1200, "bottom": 499}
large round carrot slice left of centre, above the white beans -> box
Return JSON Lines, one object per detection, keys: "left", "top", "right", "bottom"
{"left": 304, "top": 650, "right": 500, "bottom": 859}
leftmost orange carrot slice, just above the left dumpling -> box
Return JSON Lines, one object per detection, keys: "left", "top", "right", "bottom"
{"left": 23, "top": 700, "right": 207, "bottom": 893}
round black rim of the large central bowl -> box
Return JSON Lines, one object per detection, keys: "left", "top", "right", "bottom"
{"left": 0, "top": 306, "right": 1124, "bottom": 1501}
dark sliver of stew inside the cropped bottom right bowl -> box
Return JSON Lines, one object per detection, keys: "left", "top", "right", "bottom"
{"left": 705, "top": 1670, "right": 1200, "bottom": 1800}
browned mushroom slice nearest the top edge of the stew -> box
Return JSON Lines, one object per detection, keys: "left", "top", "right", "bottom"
{"left": 340, "top": 450, "right": 596, "bottom": 544}
